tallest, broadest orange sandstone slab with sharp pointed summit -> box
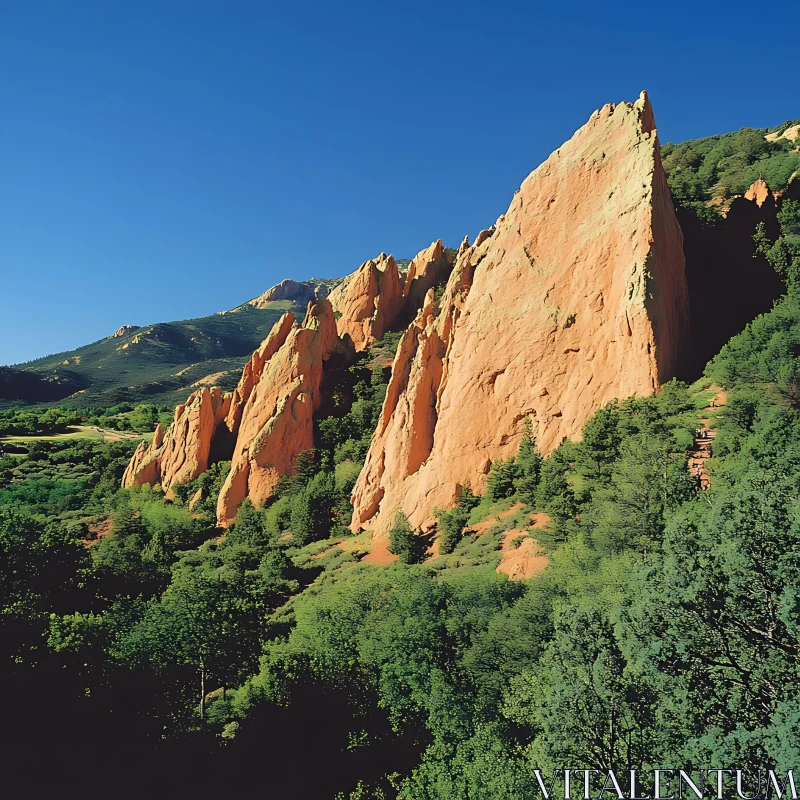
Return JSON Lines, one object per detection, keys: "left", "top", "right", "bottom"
{"left": 352, "top": 93, "right": 688, "bottom": 534}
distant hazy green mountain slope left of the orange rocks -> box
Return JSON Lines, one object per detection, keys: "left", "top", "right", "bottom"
{"left": 6, "top": 302, "right": 303, "bottom": 406}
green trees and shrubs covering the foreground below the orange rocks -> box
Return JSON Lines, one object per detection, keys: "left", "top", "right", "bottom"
{"left": 0, "top": 191, "right": 800, "bottom": 800}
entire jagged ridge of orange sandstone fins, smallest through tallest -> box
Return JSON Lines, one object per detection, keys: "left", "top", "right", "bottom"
{"left": 125, "top": 93, "right": 700, "bottom": 544}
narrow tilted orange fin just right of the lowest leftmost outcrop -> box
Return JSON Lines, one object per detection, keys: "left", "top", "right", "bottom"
{"left": 217, "top": 298, "right": 339, "bottom": 527}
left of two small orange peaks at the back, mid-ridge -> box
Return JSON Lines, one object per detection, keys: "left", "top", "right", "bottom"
{"left": 328, "top": 253, "right": 405, "bottom": 350}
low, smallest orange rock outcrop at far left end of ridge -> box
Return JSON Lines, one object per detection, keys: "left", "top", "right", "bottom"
{"left": 122, "top": 386, "right": 231, "bottom": 497}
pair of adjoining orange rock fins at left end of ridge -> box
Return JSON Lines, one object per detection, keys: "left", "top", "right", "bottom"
{"left": 122, "top": 298, "right": 339, "bottom": 526}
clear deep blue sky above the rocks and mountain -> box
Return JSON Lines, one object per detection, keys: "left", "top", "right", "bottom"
{"left": 0, "top": 0, "right": 800, "bottom": 364}
